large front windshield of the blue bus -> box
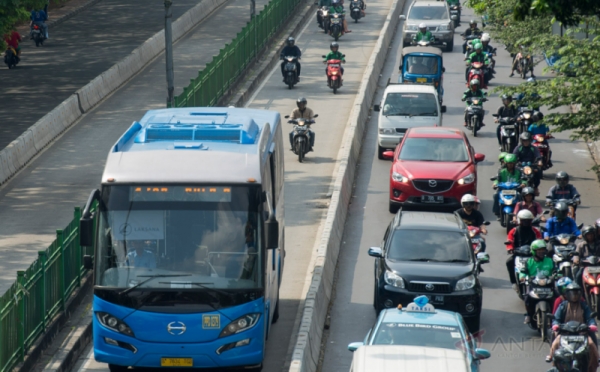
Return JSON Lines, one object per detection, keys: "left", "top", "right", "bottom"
{"left": 96, "top": 185, "right": 263, "bottom": 290}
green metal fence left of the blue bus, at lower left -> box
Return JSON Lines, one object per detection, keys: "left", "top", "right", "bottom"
{"left": 0, "top": 207, "right": 92, "bottom": 372}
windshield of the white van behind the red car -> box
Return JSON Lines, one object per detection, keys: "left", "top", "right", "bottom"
{"left": 383, "top": 93, "right": 438, "bottom": 116}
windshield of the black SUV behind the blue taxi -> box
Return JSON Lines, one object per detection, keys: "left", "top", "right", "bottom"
{"left": 387, "top": 229, "right": 471, "bottom": 262}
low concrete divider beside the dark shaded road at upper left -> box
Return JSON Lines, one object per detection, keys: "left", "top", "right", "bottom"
{"left": 0, "top": 0, "right": 228, "bottom": 185}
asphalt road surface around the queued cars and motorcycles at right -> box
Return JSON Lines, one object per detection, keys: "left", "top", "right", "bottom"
{"left": 321, "top": 5, "right": 600, "bottom": 372}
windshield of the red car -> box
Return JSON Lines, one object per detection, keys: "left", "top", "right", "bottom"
{"left": 399, "top": 137, "right": 469, "bottom": 162}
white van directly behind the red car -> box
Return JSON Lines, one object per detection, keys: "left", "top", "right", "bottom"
{"left": 373, "top": 84, "right": 443, "bottom": 159}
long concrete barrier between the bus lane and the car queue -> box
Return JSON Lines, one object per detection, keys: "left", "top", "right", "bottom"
{"left": 289, "top": 0, "right": 406, "bottom": 372}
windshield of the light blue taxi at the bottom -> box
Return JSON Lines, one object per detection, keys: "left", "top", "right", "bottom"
{"left": 372, "top": 323, "right": 462, "bottom": 350}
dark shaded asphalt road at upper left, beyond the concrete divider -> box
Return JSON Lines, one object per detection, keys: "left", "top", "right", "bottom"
{"left": 0, "top": 0, "right": 216, "bottom": 149}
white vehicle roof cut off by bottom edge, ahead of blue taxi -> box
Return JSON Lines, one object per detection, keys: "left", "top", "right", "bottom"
{"left": 350, "top": 345, "right": 469, "bottom": 372}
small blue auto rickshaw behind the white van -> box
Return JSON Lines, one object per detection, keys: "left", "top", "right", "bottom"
{"left": 398, "top": 47, "right": 446, "bottom": 111}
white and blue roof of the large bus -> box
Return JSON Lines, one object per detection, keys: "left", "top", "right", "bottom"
{"left": 102, "top": 107, "right": 280, "bottom": 184}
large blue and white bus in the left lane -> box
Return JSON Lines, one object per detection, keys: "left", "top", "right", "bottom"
{"left": 80, "top": 107, "right": 285, "bottom": 372}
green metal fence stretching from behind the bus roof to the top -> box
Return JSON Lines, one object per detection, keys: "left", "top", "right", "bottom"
{"left": 175, "top": 0, "right": 301, "bottom": 107}
